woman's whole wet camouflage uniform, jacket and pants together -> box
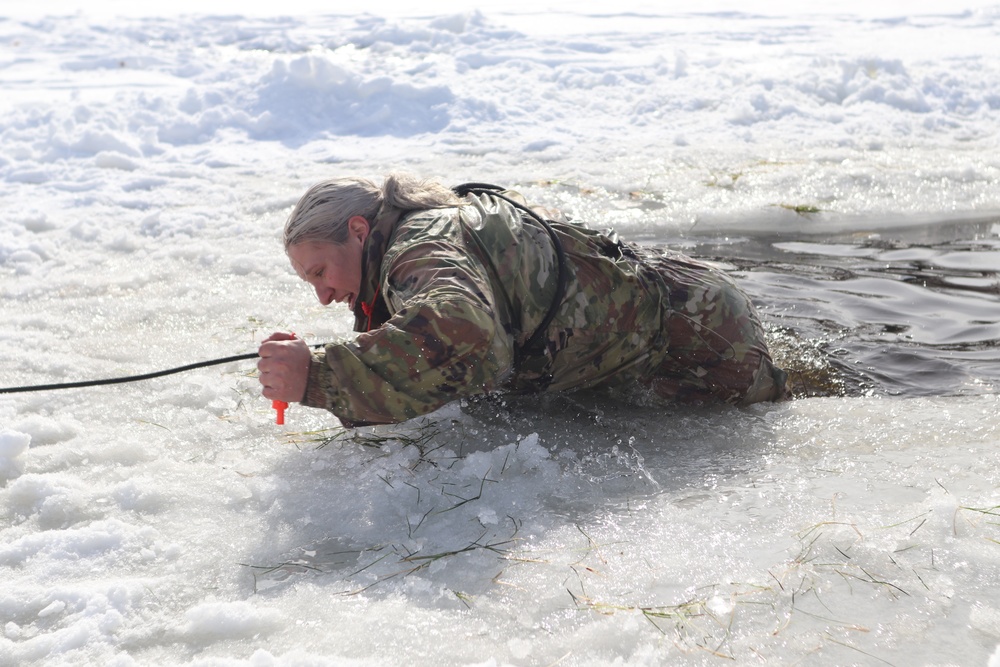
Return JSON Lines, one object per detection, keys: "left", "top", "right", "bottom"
{"left": 303, "top": 192, "right": 784, "bottom": 425}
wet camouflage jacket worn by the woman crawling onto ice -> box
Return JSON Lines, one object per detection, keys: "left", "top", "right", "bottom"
{"left": 303, "top": 192, "right": 667, "bottom": 425}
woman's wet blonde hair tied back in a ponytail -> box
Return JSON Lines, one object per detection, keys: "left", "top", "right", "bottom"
{"left": 285, "top": 174, "right": 461, "bottom": 251}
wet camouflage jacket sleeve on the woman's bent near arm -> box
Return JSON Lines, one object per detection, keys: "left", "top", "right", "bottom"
{"left": 305, "top": 204, "right": 512, "bottom": 423}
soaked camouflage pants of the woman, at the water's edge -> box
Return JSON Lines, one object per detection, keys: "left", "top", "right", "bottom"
{"left": 642, "top": 251, "right": 788, "bottom": 405}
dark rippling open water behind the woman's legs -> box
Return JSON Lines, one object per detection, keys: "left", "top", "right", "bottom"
{"left": 684, "top": 220, "right": 1000, "bottom": 396}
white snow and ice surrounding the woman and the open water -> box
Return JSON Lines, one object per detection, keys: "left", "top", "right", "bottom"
{"left": 0, "top": 0, "right": 1000, "bottom": 667}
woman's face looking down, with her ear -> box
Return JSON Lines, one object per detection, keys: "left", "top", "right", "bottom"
{"left": 288, "top": 216, "right": 368, "bottom": 310}
